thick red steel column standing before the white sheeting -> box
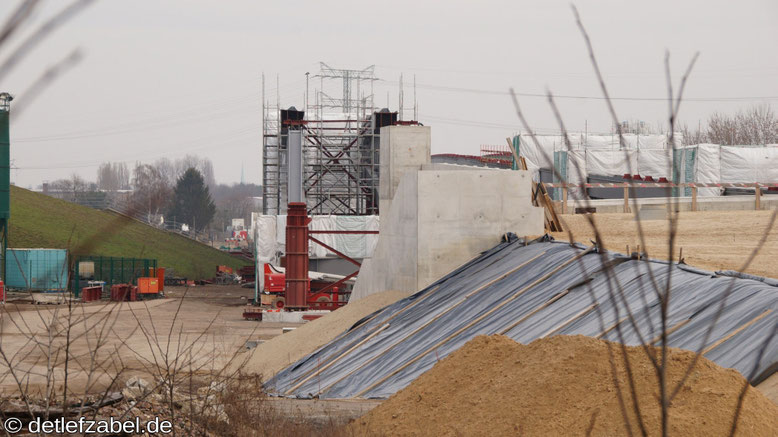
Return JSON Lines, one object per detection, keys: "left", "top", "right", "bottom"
{"left": 284, "top": 202, "right": 309, "bottom": 310}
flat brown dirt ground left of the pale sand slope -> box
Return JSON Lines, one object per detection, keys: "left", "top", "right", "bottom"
{"left": 0, "top": 286, "right": 298, "bottom": 396}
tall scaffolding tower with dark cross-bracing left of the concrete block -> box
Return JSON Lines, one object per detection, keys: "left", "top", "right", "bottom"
{"left": 262, "top": 62, "right": 415, "bottom": 215}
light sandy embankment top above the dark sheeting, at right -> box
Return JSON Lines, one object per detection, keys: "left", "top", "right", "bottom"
{"left": 552, "top": 211, "right": 778, "bottom": 278}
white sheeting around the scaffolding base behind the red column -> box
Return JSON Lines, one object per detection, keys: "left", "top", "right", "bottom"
{"left": 252, "top": 214, "right": 379, "bottom": 265}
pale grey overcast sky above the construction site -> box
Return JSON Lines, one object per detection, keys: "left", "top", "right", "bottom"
{"left": 0, "top": 0, "right": 778, "bottom": 187}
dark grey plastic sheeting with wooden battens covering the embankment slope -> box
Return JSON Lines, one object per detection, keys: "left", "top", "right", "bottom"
{"left": 265, "top": 234, "right": 778, "bottom": 398}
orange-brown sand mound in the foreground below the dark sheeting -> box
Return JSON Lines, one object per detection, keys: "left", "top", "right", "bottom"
{"left": 350, "top": 336, "right": 778, "bottom": 437}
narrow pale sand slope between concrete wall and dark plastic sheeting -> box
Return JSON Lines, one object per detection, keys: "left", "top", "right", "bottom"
{"left": 245, "top": 290, "right": 410, "bottom": 380}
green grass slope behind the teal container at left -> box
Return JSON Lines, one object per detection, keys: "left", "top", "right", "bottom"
{"left": 8, "top": 186, "right": 244, "bottom": 279}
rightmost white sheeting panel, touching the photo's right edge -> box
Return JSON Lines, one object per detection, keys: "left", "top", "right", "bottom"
{"left": 721, "top": 146, "right": 778, "bottom": 182}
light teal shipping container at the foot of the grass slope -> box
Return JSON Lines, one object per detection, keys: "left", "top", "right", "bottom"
{"left": 5, "top": 249, "right": 68, "bottom": 291}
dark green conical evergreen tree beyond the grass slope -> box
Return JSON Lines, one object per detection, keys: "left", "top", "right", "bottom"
{"left": 169, "top": 167, "right": 216, "bottom": 231}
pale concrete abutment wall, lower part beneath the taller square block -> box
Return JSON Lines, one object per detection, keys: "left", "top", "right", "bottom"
{"left": 351, "top": 167, "right": 543, "bottom": 300}
